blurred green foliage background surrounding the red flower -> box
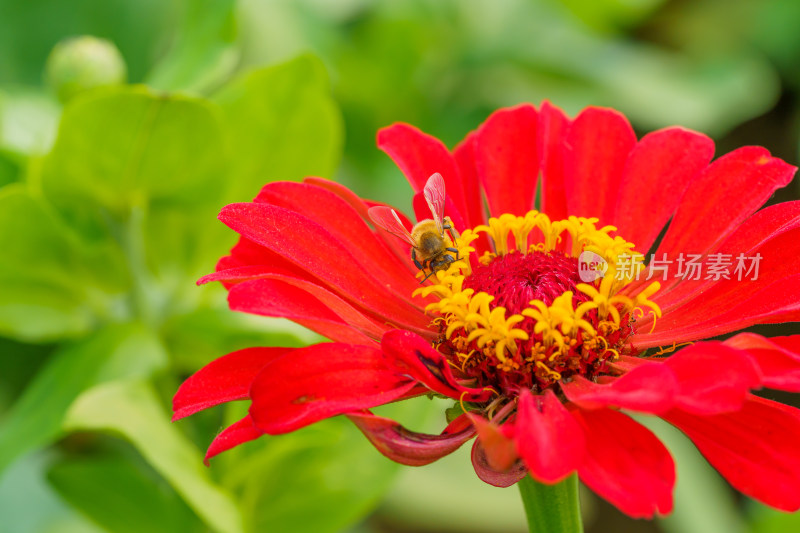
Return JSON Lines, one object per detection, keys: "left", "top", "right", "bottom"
{"left": 0, "top": 0, "right": 800, "bottom": 533}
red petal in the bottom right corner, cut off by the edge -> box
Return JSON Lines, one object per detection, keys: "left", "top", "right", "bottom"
{"left": 663, "top": 396, "right": 800, "bottom": 512}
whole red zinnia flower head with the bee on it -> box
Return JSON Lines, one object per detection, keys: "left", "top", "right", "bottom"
{"left": 174, "top": 103, "right": 800, "bottom": 517}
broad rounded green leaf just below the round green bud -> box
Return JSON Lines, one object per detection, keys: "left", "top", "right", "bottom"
{"left": 41, "top": 87, "right": 225, "bottom": 226}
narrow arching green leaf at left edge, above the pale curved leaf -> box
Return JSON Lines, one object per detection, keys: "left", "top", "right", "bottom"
{"left": 0, "top": 324, "right": 166, "bottom": 472}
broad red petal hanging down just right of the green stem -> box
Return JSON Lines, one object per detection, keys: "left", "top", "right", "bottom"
{"left": 573, "top": 409, "right": 675, "bottom": 518}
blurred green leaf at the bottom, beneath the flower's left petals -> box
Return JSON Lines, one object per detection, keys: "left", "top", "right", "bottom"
{"left": 219, "top": 398, "right": 441, "bottom": 533}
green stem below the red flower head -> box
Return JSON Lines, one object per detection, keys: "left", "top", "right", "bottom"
{"left": 517, "top": 474, "right": 583, "bottom": 533}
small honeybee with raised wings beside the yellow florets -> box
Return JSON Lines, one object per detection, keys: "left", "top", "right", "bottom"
{"left": 368, "top": 172, "right": 460, "bottom": 283}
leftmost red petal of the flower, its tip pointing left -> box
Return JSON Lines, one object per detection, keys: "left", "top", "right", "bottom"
{"left": 172, "top": 348, "right": 294, "bottom": 421}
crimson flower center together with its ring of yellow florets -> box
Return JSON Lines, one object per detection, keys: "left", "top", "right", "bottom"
{"left": 415, "top": 211, "right": 660, "bottom": 396}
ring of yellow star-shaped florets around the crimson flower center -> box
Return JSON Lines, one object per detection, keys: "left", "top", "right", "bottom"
{"left": 414, "top": 211, "right": 661, "bottom": 379}
